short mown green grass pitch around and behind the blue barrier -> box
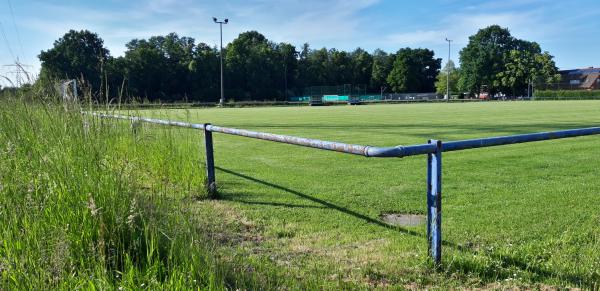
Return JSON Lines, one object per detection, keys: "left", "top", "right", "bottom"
{"left": 138, "top": 101, "right": 600, "bottom": 288}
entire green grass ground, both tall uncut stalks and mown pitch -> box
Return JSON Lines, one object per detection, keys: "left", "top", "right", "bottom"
{"left": 0, "top": 101, "right": 600, "bottom": 289}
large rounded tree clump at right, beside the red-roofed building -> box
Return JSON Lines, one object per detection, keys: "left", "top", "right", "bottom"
{"left": 435, "top": 25, "right": 560, "bottom": 96}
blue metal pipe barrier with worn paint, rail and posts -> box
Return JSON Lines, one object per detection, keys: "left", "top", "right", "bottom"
{"left": 84, "top": 112, "right": 600, "bottom": 264}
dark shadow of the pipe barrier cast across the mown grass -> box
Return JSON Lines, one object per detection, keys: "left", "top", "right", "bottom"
{"left": 215, "top": 167, "right": 598, "bottom": 289}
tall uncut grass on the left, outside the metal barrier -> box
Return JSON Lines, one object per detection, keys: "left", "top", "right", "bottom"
{"left": 0, "top": 99, "right": 260, "bottom": 290}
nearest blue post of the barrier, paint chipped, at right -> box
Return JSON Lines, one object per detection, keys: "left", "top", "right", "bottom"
{"left": 427, "top": 140, "right": 442, "bottom": 265}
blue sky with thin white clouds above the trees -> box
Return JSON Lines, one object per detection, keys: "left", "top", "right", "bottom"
{"left": 0, "top": 0, "right": 600, "bottom": 84}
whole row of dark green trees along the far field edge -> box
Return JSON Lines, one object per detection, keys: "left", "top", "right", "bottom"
{"left": 29, "top": 26, "right": 556, "bottom": 102}
